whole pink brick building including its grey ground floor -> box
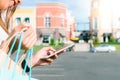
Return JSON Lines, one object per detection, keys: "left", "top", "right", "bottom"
{"left": 36, "top": 3, "right": 75, "bottom": 41}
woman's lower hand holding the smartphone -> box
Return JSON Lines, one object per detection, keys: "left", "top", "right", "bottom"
{"left": 28, "top": 47, "right": 57, "bottom": 67}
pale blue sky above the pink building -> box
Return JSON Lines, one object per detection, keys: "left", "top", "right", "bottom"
{"left": 21, "top": 0, "right": 90, "bottom": 22}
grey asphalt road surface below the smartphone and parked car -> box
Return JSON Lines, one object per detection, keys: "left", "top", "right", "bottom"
{"left": 32, "top": 52, "right": 120, "bottom": 80}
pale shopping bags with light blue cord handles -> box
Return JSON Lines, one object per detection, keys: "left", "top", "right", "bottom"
{"left": 0, "top": 32, "right": 37, "bottom": 80}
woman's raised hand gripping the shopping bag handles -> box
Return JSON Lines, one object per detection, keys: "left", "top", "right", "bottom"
{"left": 11, "top": 23, "right": 37, "bottom": 50}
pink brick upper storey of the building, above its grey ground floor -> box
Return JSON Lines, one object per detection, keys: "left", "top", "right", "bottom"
{"left": 37, "top": 3, "right": 66, "bottom": 28}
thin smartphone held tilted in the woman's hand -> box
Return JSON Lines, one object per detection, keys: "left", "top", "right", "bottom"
{"left": 42, "top": 44, "right": 74, "bottom": 59}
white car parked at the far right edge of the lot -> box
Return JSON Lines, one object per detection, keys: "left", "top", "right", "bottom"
{"left": 92, "top": 44, "right": 116, "bottom": 52}
